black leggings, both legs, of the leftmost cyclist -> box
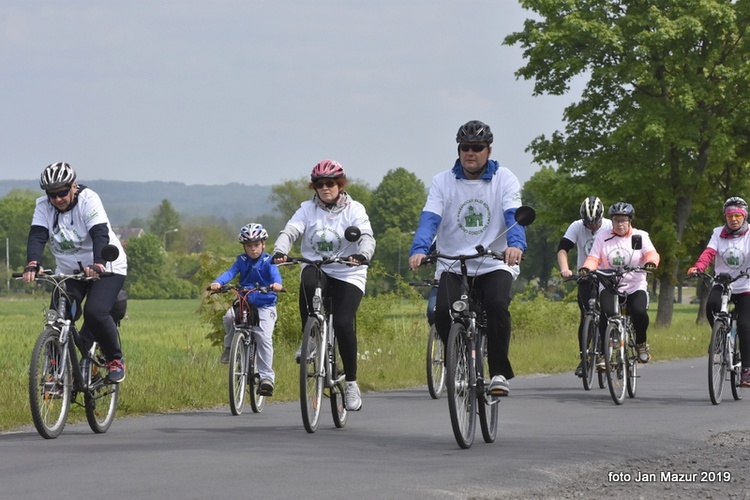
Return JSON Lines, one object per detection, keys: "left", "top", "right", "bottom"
{"left": 59, "top": 274, "right": 125, "bottom": 361}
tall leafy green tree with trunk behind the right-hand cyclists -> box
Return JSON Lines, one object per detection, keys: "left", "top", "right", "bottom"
{"left": 505, "top": 0, "right": 750, "bottom": 325}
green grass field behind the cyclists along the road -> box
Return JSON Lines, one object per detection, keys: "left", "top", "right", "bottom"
{"left": 0, "top": 296, "right": 709, "bottom": 430}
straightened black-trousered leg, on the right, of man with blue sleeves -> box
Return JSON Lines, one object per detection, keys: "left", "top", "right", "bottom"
{"left": 474, "top": 270, "right": 514, "bottom": 380}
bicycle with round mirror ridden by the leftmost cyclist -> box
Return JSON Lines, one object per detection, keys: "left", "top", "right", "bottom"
{"left": 13, "top": 246, "right": 125, "bottom": 439}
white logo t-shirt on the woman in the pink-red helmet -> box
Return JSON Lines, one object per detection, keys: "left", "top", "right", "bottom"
{"left": 287, "top": 200, "right": 372, "bottom": 293}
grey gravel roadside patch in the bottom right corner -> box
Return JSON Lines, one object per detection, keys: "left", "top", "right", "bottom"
{"left": 492, "top": 431, "right": 750, "bottom": 500}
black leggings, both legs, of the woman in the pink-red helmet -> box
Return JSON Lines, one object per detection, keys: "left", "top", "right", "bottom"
{"left": 299, "top": 266, "right": 364, "bottom": 381}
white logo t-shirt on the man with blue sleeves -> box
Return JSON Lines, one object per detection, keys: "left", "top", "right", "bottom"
{"left": 424, "top": 167, "right": 521, "bottom": 279}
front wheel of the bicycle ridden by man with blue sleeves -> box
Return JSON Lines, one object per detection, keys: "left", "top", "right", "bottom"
{"left": 446, "top": 323, "right": 477, "bottom": 449}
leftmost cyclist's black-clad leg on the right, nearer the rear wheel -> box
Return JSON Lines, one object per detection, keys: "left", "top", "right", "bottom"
{"left": 81, "top": 274, "right": 125, "bottom": 361}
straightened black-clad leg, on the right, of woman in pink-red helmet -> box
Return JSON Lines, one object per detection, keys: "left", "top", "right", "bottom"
{"left": 329, "top": 278, "right": 364, "bottom": 382}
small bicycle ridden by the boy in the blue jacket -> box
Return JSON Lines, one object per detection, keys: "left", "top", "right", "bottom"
{"left": 208, "top": 284, "right": 285, "bottom": 415}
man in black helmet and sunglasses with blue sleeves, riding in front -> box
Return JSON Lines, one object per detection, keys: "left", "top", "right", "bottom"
{"left": 409, "top": 120, "right": 526, "bottom": 396}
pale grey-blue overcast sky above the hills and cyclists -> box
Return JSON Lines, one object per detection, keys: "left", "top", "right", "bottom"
{"left": 0, "top": 0, "right": 580, "bottom": 187}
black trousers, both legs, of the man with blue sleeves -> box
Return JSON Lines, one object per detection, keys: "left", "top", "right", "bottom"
{"left": 435, "top": 270, "right": 513, "bottom": 380}
